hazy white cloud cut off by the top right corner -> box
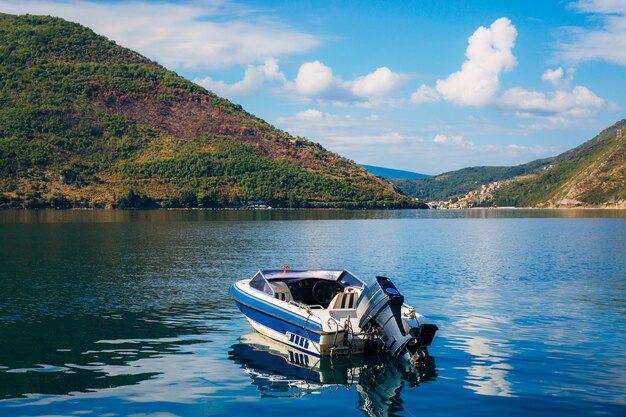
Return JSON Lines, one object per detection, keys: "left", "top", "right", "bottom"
{"left": 555, "top": 0, "right": 626, "bottom": 66}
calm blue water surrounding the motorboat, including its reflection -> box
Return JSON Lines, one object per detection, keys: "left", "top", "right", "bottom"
{"left": 0, "top": 210, "right": 626, "bottom": 417}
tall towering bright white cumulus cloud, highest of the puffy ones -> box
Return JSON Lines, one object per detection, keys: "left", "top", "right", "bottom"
{"left": 437, "top": 17, "right": 517, "bottom": 106}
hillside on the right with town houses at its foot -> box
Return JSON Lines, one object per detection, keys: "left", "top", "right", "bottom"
{"left": 394, "top": 120, "right": 626, "bottom": 207}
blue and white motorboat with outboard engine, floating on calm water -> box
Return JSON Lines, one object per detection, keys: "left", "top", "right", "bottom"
{"left": 230, "top": 267, "right": 438, "bottom": 361}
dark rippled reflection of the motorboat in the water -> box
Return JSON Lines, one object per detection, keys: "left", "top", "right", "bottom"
{"left": 229, "top": 332, "right": 437, "bottom": 416}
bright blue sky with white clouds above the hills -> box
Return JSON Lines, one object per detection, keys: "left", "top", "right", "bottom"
{"left": 0, "top": 0, "right": 626, "bottom": 174}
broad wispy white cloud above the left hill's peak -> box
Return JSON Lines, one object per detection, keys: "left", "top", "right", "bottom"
{"left": 0, "top": 0, "right": 322, "bottom": 68}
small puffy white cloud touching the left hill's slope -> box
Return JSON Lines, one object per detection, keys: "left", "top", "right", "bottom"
{"left": 194, "top": 58, "right": 287, "bottom": 97}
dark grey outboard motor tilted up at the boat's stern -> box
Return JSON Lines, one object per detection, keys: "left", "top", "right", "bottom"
{"left": 357, "top": 277, "right": 438, "bottom": 358}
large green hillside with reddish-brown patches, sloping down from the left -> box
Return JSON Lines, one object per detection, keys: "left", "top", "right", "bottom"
{"left": 0, "top": 14, "right": 421, "bottom": 207}
